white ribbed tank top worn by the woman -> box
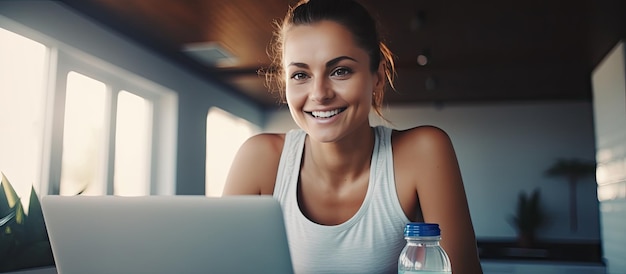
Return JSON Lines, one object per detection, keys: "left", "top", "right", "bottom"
{"left": 274, "top": 126, "right": 409, "bottom": 274}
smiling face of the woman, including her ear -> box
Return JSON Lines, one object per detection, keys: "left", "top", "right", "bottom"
{"left": 283, "top": 21, "right": 383, "bottom": 142}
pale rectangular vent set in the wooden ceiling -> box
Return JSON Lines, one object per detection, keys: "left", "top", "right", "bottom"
{"left": 182, "top": 42, "right": 237, "bottom": 67}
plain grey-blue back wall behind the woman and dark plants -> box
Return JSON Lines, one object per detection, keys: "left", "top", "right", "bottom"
{"left": 265, "top": 101, "right": 600, "bottom": 241}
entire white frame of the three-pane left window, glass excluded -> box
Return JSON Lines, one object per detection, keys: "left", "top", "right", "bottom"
{"left": 0, "top": 15, "right": 178, "bottom": 196}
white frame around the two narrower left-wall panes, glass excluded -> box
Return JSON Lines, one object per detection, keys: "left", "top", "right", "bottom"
{"left": 49, "top": 49, "right": 176, "bottom": 195}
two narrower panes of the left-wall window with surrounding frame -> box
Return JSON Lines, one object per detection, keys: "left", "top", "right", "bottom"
{"left": 53, "top": 60, "right": 176, "bottom": 196}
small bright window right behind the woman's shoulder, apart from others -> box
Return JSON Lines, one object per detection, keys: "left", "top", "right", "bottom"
{"left": 206, "top": 107, "right": 258, "bottom": 197}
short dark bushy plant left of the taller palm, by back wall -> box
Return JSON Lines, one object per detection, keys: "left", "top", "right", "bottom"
{"left": 509, "top": 189, "right": 546, "bottom": 248}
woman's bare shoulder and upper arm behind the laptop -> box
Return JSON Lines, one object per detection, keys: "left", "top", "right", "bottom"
{"left": 222, "top": 134, "right": 284, "bottom": 196}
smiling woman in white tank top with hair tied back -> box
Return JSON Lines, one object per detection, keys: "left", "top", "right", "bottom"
{"left": 224, "top": 0, "right": 482, "bottom": 274}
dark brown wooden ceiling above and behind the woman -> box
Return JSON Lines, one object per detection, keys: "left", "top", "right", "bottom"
{"left": 56, "top": 0, "right": 626, "bottom": 108}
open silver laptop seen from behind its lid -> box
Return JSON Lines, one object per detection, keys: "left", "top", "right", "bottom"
{"left": 41, "top": 195, "right": 293, "bottom": 274}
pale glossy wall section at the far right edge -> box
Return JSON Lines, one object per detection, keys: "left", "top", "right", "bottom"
{"left": 592, "top": 42, "right": 626, "bottom": 274}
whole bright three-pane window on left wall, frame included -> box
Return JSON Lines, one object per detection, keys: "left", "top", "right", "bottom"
{"left": 0, "top": 20, "right": 178, "bottom": 198}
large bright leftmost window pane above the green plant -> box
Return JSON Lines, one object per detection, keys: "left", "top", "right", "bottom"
{"left": 0, "top": 28, "right": 47, "bottom": 210}
